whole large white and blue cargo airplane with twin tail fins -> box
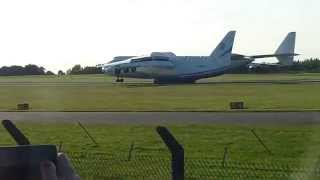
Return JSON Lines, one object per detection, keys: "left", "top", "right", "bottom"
{"left": 101, "top": 31, "right": 297, "bottom": 84}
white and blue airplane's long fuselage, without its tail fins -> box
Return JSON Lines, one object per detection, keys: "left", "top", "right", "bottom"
{"left": 103, "top": 55, "right": 252, "bottom": 82}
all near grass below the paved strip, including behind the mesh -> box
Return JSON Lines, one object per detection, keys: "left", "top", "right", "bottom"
{"left": 0, "top": 123, "right": 320, "bottom": 179}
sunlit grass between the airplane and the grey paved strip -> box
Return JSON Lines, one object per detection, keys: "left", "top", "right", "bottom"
{"left": 0, "top": 74, "right": 320, "bottom": 111}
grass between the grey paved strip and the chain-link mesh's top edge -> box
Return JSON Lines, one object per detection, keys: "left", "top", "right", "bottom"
{"left": 0, "top": 123, "right": 320, "bottom": 162}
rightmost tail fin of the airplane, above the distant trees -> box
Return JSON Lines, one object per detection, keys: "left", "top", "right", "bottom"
{"left": 275, "top": 32, "right": 296, "bottom": 65}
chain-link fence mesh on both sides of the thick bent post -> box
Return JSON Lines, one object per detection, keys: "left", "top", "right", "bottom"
{"left": 68, "top": 153, "right": 320, "bottom": 180}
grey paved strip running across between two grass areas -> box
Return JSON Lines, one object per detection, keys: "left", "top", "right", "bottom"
{"left": 0, "top": 112, "right": 320, "bottom": 124}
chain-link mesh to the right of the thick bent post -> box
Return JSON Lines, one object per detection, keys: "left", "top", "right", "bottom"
{"left": 185, "top": 158, "right": 320, "bottom": 180}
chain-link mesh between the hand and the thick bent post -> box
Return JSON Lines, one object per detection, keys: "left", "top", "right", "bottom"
{"left": 68, "top": 153, "right": 170, "bottom": 180}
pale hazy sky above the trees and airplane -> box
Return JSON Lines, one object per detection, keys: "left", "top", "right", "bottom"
{"left": 0, "top": 0, "right": 320, "bottom": 71}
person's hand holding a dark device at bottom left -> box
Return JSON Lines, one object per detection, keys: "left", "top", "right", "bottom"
{"left": 40, "top": 153, "right": 80, "bottom": 180}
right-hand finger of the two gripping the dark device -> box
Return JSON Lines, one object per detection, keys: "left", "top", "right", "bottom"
{"left": 57, "top": 153, "right": 75, "bottom": 177}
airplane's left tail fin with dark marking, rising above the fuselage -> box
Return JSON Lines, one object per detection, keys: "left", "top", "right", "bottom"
{"left": 210, "top": 31, "right": 236, "bottom": 64}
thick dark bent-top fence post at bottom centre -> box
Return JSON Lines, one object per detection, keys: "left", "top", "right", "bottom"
{"left": 157, "top": 126, "right": 184, "bottom": 180}
